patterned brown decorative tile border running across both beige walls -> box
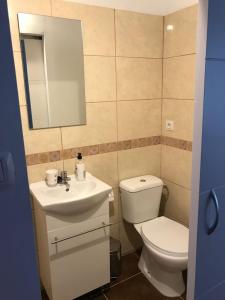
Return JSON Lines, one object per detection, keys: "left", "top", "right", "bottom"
{"left": 26, "top": 136, "right": 192, "bottom": 166}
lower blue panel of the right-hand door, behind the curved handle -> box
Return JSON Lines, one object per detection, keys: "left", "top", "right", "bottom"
{"left": 195, "top": 186, "right": 225, "bottom": 300}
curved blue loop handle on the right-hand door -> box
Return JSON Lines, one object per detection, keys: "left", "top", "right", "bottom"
{"left": 206, "top": 189, "right": 219, "bottom": 235}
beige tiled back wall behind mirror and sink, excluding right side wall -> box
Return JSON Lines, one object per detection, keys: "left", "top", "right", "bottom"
{"left": 8, "top": 0, "right": 163, "bottom": 252}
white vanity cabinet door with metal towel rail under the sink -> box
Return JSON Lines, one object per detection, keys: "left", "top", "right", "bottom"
{"left": 48, "top": 216, "right": 110, "bottom": 300}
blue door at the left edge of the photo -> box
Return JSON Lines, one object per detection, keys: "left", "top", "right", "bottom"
{"left": 0, "top": 0, "right": 41, "bottom": 300}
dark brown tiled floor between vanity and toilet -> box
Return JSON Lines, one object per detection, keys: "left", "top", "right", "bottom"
{"left": 42, "top": 253, "right": 186, "bottom": 300}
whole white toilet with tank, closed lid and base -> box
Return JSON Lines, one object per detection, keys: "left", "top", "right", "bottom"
{"left": 120, "top": 175, "right": 189, "bottom": 297}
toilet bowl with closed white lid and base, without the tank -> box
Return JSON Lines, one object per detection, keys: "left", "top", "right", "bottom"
{"left": 134, "top": 217, "right": 188, "bottom": 297}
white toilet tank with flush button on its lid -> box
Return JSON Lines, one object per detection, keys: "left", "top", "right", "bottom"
{"left": 120, "top": 175, "right": 163, "bottom": 223}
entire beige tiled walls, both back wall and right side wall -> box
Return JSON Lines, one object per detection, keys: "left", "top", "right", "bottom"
{"left": 8, "top": 0, "right": 196, "bottom": 252}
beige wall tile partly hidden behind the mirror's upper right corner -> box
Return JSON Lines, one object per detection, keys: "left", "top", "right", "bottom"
{"left": 52, "top": 0, "right": 115, "bottom": 56}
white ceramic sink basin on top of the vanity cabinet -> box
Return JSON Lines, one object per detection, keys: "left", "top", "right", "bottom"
{"left": 30, "top": 173, "right": 112, "bottom": 214}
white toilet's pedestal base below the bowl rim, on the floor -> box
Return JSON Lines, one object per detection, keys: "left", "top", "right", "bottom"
{"left": 138, "top": 246, "right": 185, "bottom": 297}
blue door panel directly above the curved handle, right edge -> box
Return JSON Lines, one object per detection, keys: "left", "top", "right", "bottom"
{"left": 200, "top": 59, "right": 225, "bottom": 192}
